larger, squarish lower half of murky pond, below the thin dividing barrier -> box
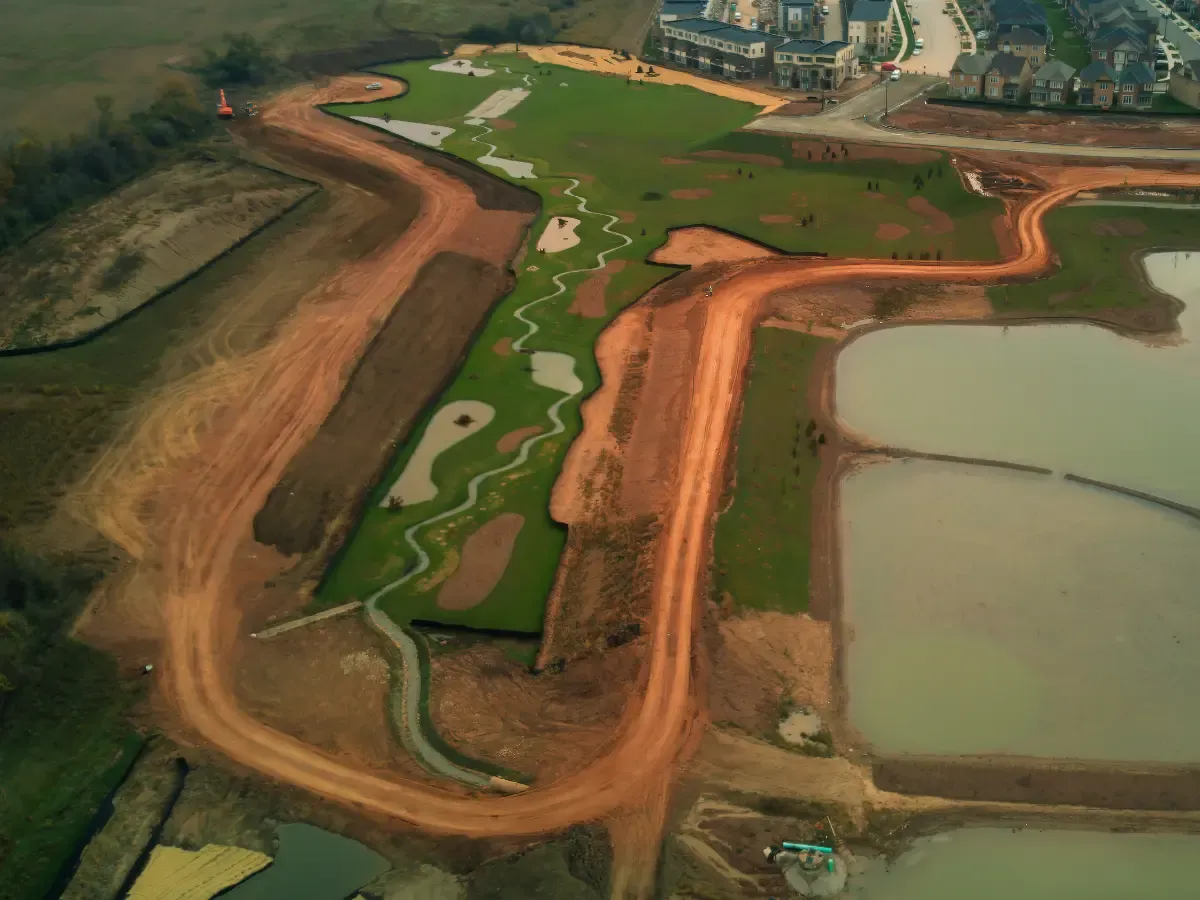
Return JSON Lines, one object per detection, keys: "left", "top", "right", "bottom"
{"left": 841, "top": 460, "right": 1200, "bottom": 762}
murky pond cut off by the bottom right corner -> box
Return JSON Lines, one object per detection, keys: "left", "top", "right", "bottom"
{"left": 847, "top": 828, "right": 1200, "bottom": 900}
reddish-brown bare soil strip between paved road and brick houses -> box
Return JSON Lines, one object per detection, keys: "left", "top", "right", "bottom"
{"left": 888, "top": 103, "right": 1200, "bottom": 149}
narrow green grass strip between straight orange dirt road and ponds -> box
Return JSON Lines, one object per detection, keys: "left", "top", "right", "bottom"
{"left": 713, "top": 328, "right": 827, "bottom": 612}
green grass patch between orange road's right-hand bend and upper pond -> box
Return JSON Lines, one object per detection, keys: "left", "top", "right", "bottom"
{"left": 988, "top": 206, "right": 1200, "bottom": 311}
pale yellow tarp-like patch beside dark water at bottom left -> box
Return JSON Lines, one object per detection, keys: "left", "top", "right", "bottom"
{"left": 128, "top": 844, "right": 271, "bottom": 900}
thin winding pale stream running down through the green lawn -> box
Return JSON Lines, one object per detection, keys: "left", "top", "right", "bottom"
{"left": 365, "top": 126, "right": 634, "bottom": 787}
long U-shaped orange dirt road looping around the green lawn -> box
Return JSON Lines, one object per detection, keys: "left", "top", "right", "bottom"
{"left": 96, "top": 75, "right": 1200, "bottom": 860}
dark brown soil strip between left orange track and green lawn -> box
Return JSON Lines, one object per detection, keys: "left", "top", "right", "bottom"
{"left": 254, "top": 248, "right": 522, "bottom": 556}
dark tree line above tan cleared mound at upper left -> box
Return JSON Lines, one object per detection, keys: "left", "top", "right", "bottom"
{"left": 0, "top": 79, "right": 212, "bottom": 251}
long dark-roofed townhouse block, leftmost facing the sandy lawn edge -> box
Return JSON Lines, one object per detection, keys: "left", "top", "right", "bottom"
{"left": 662, "top": 19, "right": 784, "bottom": 79}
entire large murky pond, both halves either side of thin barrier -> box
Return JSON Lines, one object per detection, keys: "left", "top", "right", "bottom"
{"left": 838, "top": 253, "right": 1200, "bottom": 762}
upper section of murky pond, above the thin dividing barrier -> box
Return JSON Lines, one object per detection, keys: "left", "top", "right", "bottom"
{"left": 838, "top": 253, "right": 1200, "bottom": 506}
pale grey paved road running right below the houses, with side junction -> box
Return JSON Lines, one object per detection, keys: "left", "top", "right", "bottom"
{"left": 745, "top": 80, "right": 1200, "bottom": 162}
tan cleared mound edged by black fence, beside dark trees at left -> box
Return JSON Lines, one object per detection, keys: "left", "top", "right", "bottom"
{"left": 0, "top": 161, "right": 317, "bottom": 353}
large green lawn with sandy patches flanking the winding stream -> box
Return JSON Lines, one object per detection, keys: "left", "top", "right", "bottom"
{"left": 318, "top": 56, "right": 1001, "bottom": 634}
